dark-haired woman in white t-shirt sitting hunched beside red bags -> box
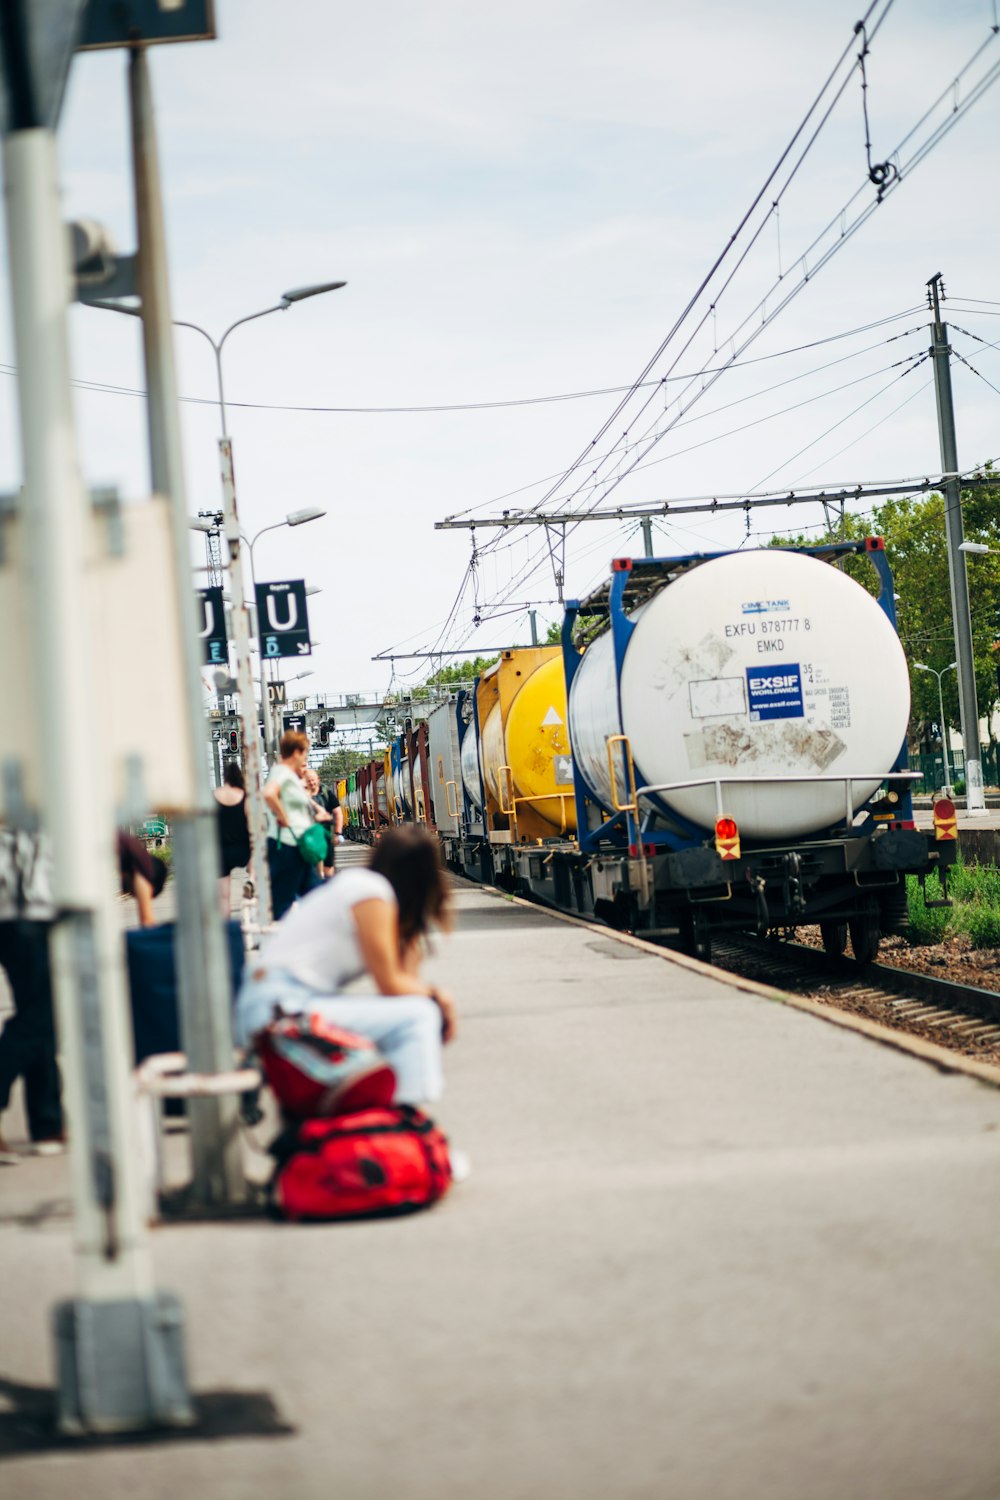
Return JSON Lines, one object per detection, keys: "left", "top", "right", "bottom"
{"left": 237, "top": 828, "right": 456, "bottom": 1104}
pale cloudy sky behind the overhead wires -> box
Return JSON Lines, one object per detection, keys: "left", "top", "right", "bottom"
{"left": 0, "top": 0, "right": 1000, "bottom": 726}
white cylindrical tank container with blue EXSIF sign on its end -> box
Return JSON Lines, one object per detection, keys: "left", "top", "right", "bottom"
{"left": 570, "top": 549, "right": 910, "bottom": 839}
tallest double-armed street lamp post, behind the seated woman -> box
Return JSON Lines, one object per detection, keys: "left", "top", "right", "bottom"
{"left": 101, "top": 282, "right": 346, "bottom": 926}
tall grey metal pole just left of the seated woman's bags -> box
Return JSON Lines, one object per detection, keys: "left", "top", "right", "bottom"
{"left": 129, "top": 47, "right": 247, "bottom": 1208}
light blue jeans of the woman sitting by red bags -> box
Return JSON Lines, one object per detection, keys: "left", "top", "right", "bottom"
{"left": 235, "top": 969, "right": 444, "bottom": 1104}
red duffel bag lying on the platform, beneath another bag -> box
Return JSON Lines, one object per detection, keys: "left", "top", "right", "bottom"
{"left": 271, "top": 1104, "right": 451, "bottom": 1220}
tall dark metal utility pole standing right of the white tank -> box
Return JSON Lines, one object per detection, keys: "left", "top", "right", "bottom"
{"left": 927, "top": 272, "right": 987, "bottom": 813}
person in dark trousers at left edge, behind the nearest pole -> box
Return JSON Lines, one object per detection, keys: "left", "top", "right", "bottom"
{"left": 0, "top": 828, "right": 66, "bottom": 1166}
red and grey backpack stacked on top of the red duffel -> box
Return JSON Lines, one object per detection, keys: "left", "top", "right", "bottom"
{"left": 253, "top": 1013, "right": 396, "bottom": 1119}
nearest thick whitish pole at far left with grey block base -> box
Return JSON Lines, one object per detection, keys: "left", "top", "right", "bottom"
{"left": 3, "top": 117, "right": 193, "bottom": 1433}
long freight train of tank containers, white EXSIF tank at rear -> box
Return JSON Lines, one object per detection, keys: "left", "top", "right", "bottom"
{"left": 339, "top": 537, "right": 957, "bottom": 963}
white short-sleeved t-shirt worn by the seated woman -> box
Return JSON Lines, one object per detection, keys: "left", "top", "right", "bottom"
{"left": 261, "top": 870, "right": 397, "bottom": 995}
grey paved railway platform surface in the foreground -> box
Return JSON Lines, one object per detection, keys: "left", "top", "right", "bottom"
{"left": 0, "top": 864, "right": 1000, "bottom": 1500}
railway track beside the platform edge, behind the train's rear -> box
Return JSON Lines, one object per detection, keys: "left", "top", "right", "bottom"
{"left": 712, "top": 938, "right": 1000, "bottom": 1064}
